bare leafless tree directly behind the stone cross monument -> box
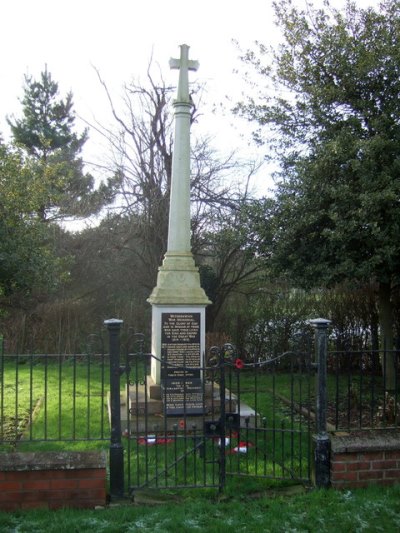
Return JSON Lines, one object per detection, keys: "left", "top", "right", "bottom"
{"left": 86, "top": 66, "right": 262, "bottom": 327}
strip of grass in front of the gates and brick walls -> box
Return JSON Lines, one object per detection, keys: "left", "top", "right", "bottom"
{"left": 0, "top": 485, "right": 400, "bottom": 533}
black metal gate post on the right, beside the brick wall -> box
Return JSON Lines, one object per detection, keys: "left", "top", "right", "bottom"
{"left": 310, "top": 318, "right": 331, "bottom": 488}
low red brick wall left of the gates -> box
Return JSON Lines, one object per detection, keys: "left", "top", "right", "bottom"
{"left": 0, "top": 453, "right": 106, "bottom": 511}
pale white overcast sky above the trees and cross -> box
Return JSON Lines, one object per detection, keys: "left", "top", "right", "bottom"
{"left": 0, "top": 0, "right": 378, "bottom": 195}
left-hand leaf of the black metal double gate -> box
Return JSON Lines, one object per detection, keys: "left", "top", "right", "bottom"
{"left": 121, "top": 328, "right": 224, "bottom": 496}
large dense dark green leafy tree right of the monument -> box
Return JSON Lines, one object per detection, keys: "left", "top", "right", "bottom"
{"left": 238, "top": 0, "right": 400, "bottom": 358}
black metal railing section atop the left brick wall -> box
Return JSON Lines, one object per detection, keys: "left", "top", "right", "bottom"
{"left": 0, "top": 352, "right": 110, "bottom": 449}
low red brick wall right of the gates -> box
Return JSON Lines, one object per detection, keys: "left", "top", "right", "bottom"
{"left": 331, "top": 436, "right": 400, "bottom": 489}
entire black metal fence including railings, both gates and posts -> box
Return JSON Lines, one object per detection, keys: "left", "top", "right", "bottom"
{"left": 5, "top": 319, "right": 394, "bottom": 497}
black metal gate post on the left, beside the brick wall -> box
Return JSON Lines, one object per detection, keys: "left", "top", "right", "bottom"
{"left": 104, "top": 318, "right": 124, "bottom": 498}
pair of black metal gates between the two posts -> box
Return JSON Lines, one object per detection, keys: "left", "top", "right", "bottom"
{"left": 109, "top": 325, "right": 315, "bottom": 496}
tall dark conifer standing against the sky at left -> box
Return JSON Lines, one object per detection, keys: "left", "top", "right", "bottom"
{"left": 8, "top": 69, "right": 99, "bottom": 221}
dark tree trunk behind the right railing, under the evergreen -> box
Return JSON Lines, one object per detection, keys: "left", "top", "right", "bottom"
{"left": 379, "top": 282, "right": 396, "bottom": 391}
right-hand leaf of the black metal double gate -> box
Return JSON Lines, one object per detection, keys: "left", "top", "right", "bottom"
{"left": 219, "top": 342, "right": 314, "bottom": 484}
